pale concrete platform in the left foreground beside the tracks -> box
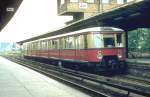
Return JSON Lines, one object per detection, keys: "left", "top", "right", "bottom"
{"left": 0, "top": 57, "right": 90, "bottom": 97}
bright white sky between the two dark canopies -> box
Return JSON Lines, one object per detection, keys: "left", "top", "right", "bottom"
{"left": 0, "top": 0, "right": 72, "bottom": 42}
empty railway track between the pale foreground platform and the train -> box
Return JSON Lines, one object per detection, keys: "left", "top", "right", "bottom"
{"left": 2, "top": 57, "right": 150, "bottom": 97}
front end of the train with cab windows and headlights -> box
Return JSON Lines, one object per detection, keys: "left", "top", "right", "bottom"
{"left": 88, "top": 28, "right": 127, "bottom": 73}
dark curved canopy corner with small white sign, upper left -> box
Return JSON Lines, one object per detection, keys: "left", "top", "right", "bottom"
{"left": 0, "top": 0, "right": 23, "bottom": 31}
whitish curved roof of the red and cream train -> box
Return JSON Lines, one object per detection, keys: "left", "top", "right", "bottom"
{"left": 17, "top": 27, "right": 123, "bottom": 44}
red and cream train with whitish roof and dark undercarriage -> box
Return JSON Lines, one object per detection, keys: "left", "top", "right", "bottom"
{"left": 23, "top": 27, "right": 127, "bottom": 72}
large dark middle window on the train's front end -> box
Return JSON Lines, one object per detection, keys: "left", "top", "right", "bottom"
{"left": 103, "top": 34, "right": 115, "bottom": 48}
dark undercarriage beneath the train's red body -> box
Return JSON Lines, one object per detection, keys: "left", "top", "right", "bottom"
{"left": 24, "top": 56, "right": 127, "bottom": 75}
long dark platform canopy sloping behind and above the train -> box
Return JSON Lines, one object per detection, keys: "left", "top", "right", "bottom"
{"left": 18, "top": 0, "right": 150, "bottom": 44}
